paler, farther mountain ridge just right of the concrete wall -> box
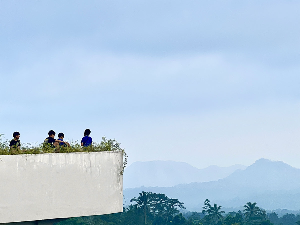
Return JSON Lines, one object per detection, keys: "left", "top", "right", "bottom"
{"left": 124, "top": 161, "right": 246, "bottom": 188}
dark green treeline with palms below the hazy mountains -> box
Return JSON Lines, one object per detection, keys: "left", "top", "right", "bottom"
{"left": 57, "top": 192, "right": 300, "bottom": 225}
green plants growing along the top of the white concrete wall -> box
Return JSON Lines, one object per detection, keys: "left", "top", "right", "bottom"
{"left": 0, "top": 134, "right": 128, "bottom": 174}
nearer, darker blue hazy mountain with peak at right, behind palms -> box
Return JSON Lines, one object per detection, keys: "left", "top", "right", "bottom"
{"left": 124, "top": 159, "right": 300, "bottom": 210}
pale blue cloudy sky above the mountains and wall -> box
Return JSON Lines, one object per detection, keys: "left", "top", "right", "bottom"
{"left": 0, "top": 0, "right": 300, "bottom": 168}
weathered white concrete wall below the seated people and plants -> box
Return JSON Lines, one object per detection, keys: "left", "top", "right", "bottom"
{"left": 0, "top": 152, "right": 123, "bottom": 223}
